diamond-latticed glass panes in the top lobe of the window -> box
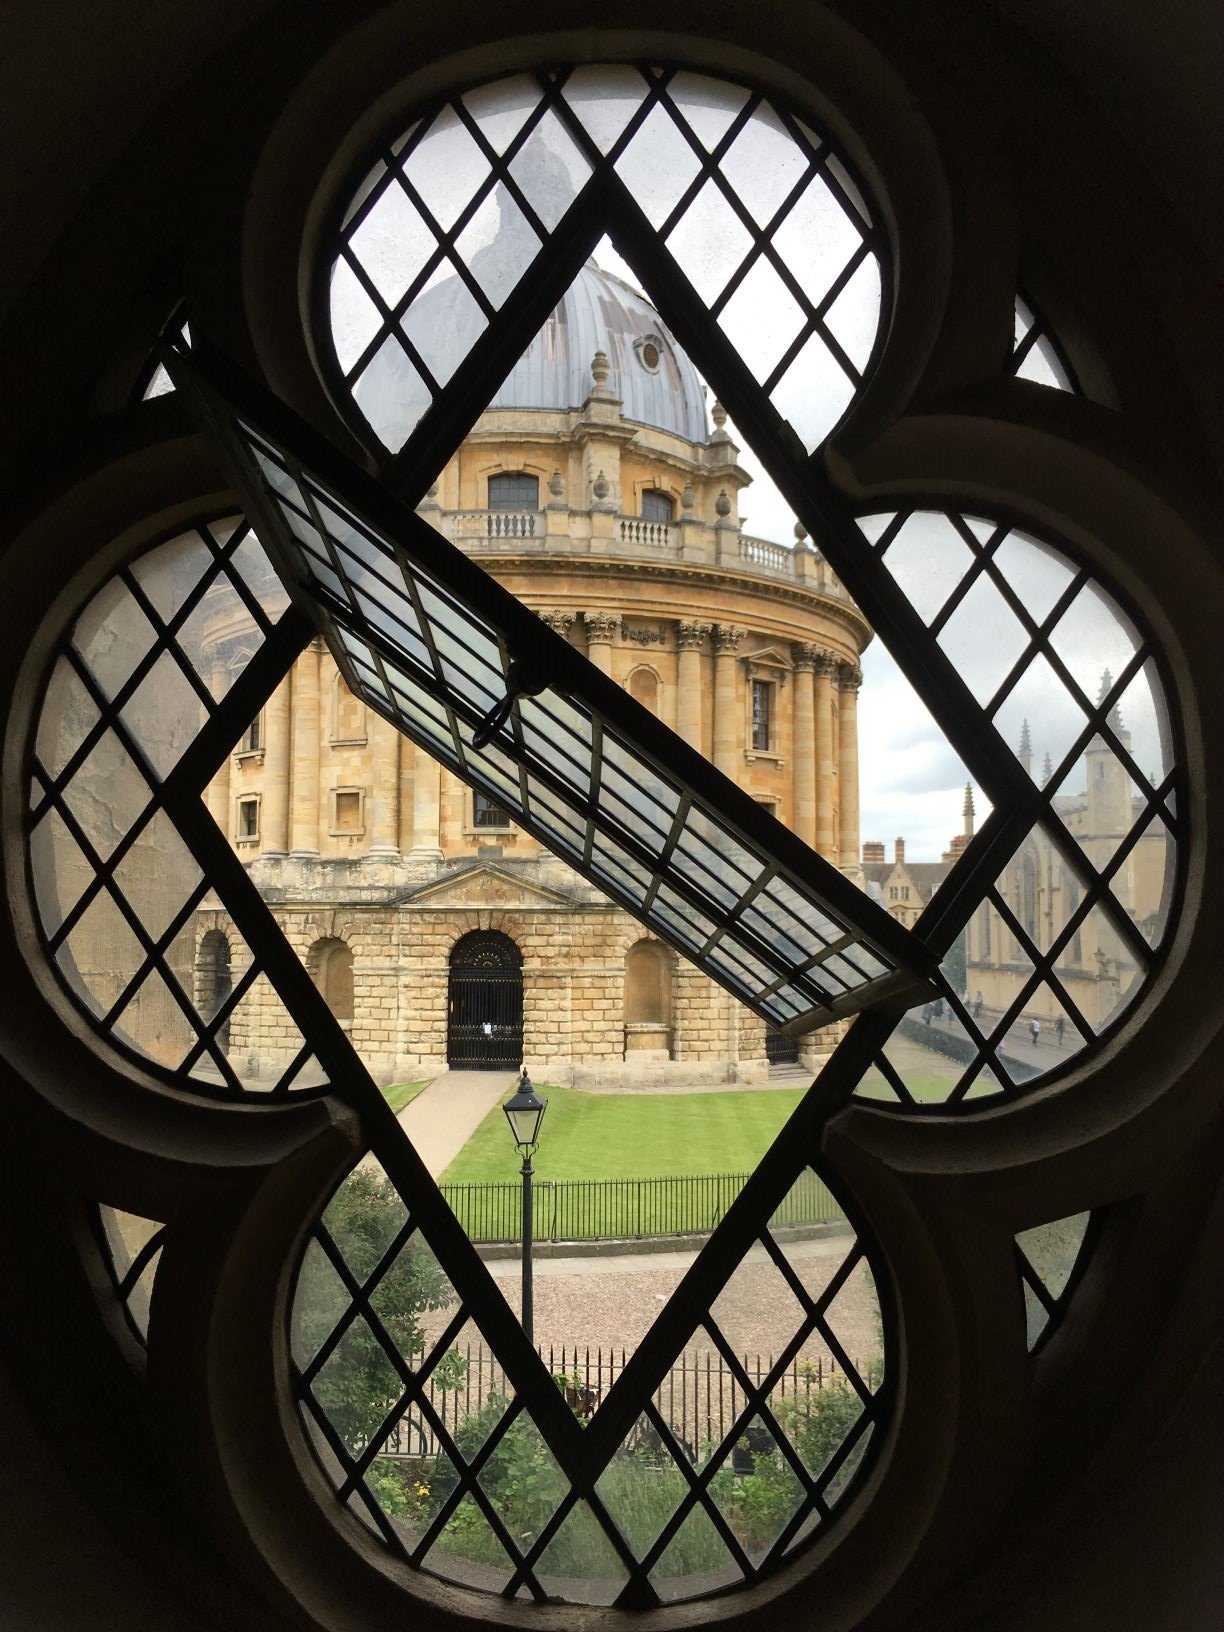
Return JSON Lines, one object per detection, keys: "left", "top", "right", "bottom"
{"left": 326, "top": 67, "right": 883, "bottom": 460}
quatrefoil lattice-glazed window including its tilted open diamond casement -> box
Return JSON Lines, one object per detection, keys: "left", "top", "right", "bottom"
{"left": 29, "top": 54, "right": 1185, "bottom": 1608}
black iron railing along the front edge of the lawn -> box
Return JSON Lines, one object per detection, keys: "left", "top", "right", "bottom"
{"left": 442, "top": 1170, "right": 842, "bottom": 1242}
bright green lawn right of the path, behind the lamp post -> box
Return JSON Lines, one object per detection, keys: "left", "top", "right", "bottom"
{"left": 442, "top": 1087, "right": 805, "bottom": 1185}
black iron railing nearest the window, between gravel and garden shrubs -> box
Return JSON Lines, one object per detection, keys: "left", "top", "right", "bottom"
{"left": 382, "top": 1343, "right": 880, "bottom": 1457}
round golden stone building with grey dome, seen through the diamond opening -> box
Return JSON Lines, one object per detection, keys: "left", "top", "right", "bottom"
{"left": 196, "top": 263, "right": 870, "bottom": 1084}
